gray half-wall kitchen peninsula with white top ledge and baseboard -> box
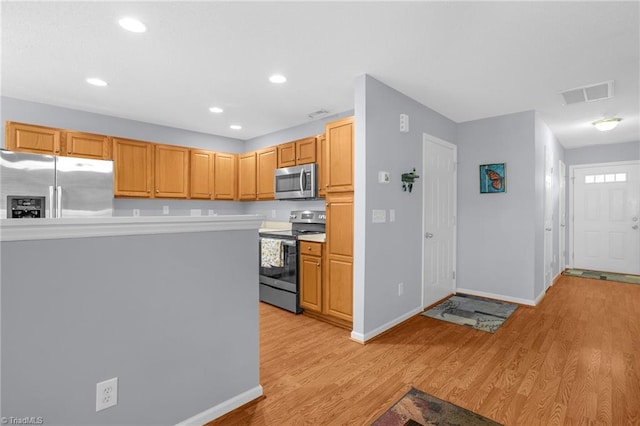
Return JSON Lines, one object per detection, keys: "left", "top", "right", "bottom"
{"left": 0, "top": 215, "right": 263, "bottom": 424}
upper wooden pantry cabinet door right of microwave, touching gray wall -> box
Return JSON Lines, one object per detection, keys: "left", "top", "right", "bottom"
{"left": 325, "top": 117, "right": 353, "bottom": 192}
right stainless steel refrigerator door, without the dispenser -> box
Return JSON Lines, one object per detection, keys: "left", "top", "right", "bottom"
{"left": 56, "top": 157, "right": 113, "bottom": 217}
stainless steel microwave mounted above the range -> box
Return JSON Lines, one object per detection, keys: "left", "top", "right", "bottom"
{"left": 274, "top": 164, "right": 318, "bottom": 200}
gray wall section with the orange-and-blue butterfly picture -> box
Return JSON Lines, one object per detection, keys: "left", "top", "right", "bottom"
{"left": 456, "top": 111, "right": 544, "bottom": 304}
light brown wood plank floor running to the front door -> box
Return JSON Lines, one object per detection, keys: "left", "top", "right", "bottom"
{"left": 211, "top": 277, "right": 640, "bottom": 426}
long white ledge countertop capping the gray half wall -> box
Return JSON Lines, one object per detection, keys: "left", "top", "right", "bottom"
{"left": 0, "top": 215, "right": 264, "bottom": 241}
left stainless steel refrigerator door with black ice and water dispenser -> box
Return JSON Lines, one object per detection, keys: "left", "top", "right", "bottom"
{"left": 0, "top": 150, "right": 55, "bottom": 219}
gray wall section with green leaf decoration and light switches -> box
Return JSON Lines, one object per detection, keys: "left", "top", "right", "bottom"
{"left": 352, "top": 75, "right": 455, "bottom": 340}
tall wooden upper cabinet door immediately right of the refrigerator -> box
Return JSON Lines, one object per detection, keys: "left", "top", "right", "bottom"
{"left": 113, "top": 138, "right": 153, "bottom": 198}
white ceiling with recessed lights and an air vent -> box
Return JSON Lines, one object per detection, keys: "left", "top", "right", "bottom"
{"left": 1, "top": 1, "right": 640, "bottom": 148}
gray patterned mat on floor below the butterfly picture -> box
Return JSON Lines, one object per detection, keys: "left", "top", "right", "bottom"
{"left": 422, "top": 294, "right": 518, "bottom": 333}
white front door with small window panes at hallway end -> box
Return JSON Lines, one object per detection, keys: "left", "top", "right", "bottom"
{"left": 573, "top": 162, "right": 640, "bottom": 274}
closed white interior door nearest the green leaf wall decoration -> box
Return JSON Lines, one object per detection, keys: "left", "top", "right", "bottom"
{"left": 422, "top": 134, "right": 457, "bottom": 307}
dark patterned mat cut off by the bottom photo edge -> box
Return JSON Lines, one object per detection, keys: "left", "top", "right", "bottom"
{"left": 372, "top": 388, "right": 501, "bottom": 426}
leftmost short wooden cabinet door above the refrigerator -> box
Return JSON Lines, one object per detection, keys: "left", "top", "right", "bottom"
{"left": 5, "top": 122, "right": 62, "bottom": 155}
